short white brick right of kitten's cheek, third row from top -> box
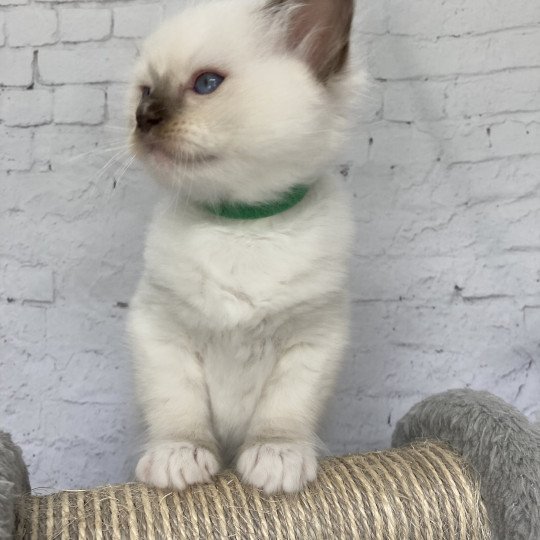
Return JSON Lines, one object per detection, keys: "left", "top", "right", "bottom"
{"left": 384, "top": 81, "right": 448, "bottom": 122}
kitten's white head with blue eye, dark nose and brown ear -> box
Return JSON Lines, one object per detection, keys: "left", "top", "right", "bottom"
{"left": 131, "top": 0, "right": 353, "bottom": 206}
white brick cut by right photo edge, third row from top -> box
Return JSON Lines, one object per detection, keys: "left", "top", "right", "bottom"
{"left": 447, "top": 69, "right": 540, "bottom": 117}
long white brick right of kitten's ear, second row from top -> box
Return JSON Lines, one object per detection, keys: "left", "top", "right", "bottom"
{"left": 370, "top": 30, "right": 540, "bottom": 79}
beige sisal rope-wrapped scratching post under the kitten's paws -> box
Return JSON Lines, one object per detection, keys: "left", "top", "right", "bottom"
{"left": 16, "top": 442, "right": 491, "bottom": 540}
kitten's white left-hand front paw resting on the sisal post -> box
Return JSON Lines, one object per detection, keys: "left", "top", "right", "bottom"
{"left": 135, "top": 442, "right": 219, "bottom": 490}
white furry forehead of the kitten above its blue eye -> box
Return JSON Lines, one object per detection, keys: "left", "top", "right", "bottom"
{"left": 139, "top": 0, "right": 266, "bottom": 84}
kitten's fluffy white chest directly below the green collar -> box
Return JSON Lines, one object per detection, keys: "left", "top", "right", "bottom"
{"left": 145, "top": 183, "right": 352, "bottom": 330}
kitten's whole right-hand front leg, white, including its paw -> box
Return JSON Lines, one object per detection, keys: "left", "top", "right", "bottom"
{"left": 237, "top": 324, "right": 346, "bottom": 494}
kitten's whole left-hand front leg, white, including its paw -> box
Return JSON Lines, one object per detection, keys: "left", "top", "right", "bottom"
{"left": 130, "top": 313, "right": 220, "bottom": 490}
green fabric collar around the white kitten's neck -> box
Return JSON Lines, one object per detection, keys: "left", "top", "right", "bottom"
{"left": 203, "top": 185, "right": 309, "bottom": 220}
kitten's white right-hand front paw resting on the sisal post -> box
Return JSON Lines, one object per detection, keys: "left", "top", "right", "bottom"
{"left": 237, "top": 442, "right": 317, "bottom": 494}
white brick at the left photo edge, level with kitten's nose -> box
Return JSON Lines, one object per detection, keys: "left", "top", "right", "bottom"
{"left": 1, "top": 89, "right": 52, "bottom": 127}
